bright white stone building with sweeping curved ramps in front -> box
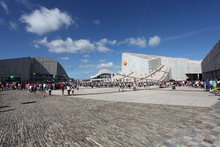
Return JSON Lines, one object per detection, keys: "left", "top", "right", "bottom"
{"left": 114, "top": 53, "right": 202, "bottom": 81}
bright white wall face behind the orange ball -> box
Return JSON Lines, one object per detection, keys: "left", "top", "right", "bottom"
{"left": 121, "top": 54, "right": 149, "bottom": 74}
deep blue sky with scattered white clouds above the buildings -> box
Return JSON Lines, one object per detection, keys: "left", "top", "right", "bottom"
{"left": 0, "top": 0, "right": 220, "bottom": 79}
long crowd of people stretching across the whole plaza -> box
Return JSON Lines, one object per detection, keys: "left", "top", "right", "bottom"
{"left": 0, "top": 79, "right": 220, "bottom": 95}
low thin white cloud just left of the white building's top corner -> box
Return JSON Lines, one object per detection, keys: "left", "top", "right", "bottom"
{"left": 79, "top": 62, "right": 120, "bottom": 69}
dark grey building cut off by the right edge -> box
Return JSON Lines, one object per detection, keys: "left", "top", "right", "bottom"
{"left": 202, "top": 40, "right": 220, "bottom": 80}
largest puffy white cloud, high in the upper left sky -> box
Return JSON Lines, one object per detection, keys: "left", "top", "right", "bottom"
{"left": 20, "top": 7, "right": 74, "bottom": 35}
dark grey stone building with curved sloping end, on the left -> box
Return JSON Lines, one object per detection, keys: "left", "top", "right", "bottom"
{"left": 0, "top": 57, "right": 69, "bottom": 81}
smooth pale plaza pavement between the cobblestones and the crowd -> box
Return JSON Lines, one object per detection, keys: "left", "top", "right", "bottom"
{"left": 52, "top": 86, "right": 219, "bottom": 107}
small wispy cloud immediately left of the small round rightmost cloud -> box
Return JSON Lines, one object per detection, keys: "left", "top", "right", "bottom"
{"left": 118, "top": 37, "right": 147, "bottom": 48}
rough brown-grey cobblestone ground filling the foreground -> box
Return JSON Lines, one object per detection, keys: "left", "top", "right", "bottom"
{"left": 0, "top": 91, "right": 220, "bottom": 147}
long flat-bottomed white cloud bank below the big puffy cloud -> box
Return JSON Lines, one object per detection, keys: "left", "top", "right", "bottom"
{"left": 34, "top": 37, "right": 116, "bottom": 53}
